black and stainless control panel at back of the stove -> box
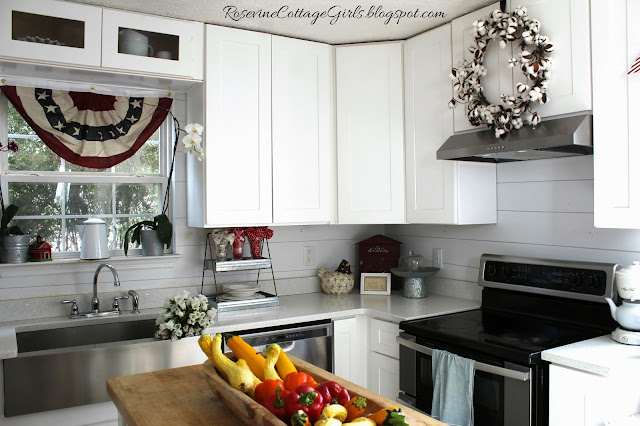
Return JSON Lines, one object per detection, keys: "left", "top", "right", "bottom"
{"left": 479, "top": 254, "right": 618, "bottom": 300}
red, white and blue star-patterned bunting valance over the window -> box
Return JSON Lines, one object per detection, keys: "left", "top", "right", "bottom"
{"left": 1, "top": 86, "right": 173, "bottom": 169}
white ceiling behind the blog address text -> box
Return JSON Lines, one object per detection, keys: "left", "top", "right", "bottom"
{"left": 66, "top": 0, "right": 494, "bottom": 44}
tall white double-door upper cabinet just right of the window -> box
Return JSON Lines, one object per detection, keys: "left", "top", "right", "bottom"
{"left": 187, "top": 25, "right": 336, "bottom": 227}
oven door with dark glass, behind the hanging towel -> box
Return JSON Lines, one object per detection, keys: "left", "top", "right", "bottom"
{"left": 397, "top": 333, "right": 537, "bottom": 426}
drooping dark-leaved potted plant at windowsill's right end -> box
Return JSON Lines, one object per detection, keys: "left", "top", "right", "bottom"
{"left": 124, "top": 213, "right": 173, "bottom": 256}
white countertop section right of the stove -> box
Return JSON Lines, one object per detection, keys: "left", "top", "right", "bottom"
{"left": 542, "top": 334, "right": 640, "bottom": 376}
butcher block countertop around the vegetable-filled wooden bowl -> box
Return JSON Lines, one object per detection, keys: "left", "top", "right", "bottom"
{"left": 107, "top": 364, "right": 444, "bottom": 426}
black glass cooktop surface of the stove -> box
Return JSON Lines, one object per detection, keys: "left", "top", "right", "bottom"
{"left": 400, "top": 289, "right": 615, "bottom": 365}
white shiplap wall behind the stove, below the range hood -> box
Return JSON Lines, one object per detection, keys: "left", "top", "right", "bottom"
{"left": 385, "top": 156, "right": 640, "bottom": 292}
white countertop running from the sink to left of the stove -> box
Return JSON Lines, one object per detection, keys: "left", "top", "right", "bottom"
{"left": 0, "top": 293, "right": 480, "bottom": 359}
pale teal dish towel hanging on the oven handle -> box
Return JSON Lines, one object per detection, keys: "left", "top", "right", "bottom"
{"left": 431, "top": 349, "right": 474, "bottom": 426}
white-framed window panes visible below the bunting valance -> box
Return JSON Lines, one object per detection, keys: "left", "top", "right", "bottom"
{"left": 0, "top": 95, "right": 172, "bottom": 257}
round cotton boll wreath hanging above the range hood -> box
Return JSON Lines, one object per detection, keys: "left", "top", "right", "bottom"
{"left": 449, "top": 6, "right": 553, "bottom": 138}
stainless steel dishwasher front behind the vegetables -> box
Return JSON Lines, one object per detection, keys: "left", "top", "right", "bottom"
{"left": 225, "top": 321, "right": 333, "bottom": 373}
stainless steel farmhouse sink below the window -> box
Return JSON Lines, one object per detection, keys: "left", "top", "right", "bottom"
{"left": 3, "top": 317, "right": 206, "bottom": 417}
